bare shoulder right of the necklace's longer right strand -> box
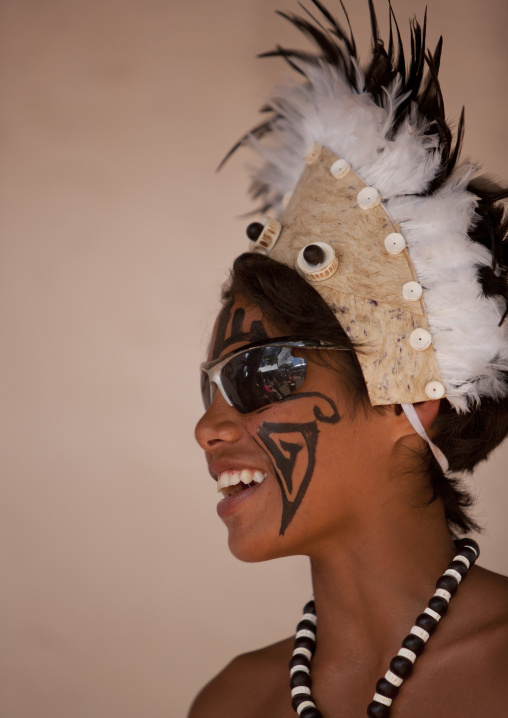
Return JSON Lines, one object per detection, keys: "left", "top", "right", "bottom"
{"left": 397, "top": 566, "right": 508, "bottom": 718}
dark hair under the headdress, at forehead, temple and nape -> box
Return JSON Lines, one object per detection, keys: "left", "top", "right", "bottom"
{"left": 222, "top": 253, "right": 508, "bottom": 533}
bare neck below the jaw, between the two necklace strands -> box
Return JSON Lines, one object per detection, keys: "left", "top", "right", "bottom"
{"left": 311, "top": 502, "right": 454, "bottom": 668}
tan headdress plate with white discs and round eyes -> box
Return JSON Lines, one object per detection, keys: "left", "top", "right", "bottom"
{"left": 252, "top": 143, "right": 445, "bottom": 406}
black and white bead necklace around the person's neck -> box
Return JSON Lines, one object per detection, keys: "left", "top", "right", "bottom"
{"left": 289, "top": 538, "right": 480, "bottom": 718}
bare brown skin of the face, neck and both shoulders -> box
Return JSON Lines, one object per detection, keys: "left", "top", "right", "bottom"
{"left": 189, "top": 298, "right": 508, "bottom": 718}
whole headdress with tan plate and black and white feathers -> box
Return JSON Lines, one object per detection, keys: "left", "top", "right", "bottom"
{"left": 228, "top": 0, "right": 508, "bottom": 412}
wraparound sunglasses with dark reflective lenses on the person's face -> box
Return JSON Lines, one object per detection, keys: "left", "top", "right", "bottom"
{"left": 200, "top": 337, "right": 348, "bottom": 414}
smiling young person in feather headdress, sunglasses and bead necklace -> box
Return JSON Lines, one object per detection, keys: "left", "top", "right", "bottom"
{"left": 190, "top": 0, "right": 508, "bottom": 718}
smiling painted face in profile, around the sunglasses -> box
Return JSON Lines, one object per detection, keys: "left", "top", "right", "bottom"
{"left": 196, "top": 297, "right": 408, "bottom": 561}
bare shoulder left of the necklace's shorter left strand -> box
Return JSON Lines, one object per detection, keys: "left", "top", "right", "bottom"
{"left": 188, "top": 639, "right": 292, "bottom": 718}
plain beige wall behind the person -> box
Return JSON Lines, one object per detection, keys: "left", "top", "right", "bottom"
{"left": 0, "top": 0, "right": 508, "bottom": 718}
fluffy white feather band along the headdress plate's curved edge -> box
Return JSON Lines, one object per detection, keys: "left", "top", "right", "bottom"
{"left": 250, "top": 62, "right": 508, "bottom": 412}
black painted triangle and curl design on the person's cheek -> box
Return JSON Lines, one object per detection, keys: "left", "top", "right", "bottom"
{"left": 257, "top": 391, "right": 340, "bottom": 536}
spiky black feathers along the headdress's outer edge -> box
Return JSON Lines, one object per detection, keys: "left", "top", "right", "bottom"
{"left": 219, "top": 0, "right": 508, "bottom": 312}
